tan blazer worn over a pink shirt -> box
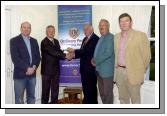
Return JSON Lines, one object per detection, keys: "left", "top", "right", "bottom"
{"left": 114, "top": 29, "right": 151, "bottom": 85}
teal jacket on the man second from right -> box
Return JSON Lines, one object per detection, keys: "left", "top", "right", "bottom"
{"left": 94, "top": 33, "right": 115, "bottom": 78}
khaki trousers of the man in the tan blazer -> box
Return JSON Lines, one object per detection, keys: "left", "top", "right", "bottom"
{"left": 115, "top": 67, "right": 141, "bottom": 104}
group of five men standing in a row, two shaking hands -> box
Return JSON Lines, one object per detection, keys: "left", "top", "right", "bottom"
{"left": 10, "top": 13, "right": 151, "bottom": 104}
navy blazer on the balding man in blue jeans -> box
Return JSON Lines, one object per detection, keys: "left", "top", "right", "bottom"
{"left": 10, "top": 34, "right": 40, "bottom": 78}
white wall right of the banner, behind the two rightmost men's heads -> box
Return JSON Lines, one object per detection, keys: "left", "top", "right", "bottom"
{"left": 92, "top": 5, "right": 152, "bottom": 35}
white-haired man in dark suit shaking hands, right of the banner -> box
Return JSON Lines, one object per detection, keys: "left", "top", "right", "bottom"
{"left": 67, "top": 24, "right": 99, "bottom": 104}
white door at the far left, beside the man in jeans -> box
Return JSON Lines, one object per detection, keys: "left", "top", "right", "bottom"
{"left": 5, "top": 8, "right": 14, "bottom": 103}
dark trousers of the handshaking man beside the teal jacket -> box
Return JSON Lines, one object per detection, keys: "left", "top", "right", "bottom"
{"left": 81, "top": 73, "right": 98, "bottom": 104}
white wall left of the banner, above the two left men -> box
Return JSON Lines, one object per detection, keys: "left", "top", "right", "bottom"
{"left": 11, "top": 5, "right": 57, "bottom": 47}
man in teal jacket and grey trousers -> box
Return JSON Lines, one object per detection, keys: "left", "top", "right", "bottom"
{"left": 92, "top": 19, "right": 115, "bottom": 104}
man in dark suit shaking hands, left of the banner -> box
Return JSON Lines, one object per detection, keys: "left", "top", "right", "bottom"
{"left": 41, "top": 25, "right": 71, "bottom": 104}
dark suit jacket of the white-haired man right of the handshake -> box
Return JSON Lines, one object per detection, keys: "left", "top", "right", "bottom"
{"left": 75, "top": 33, "right": 99, "bottom": 74}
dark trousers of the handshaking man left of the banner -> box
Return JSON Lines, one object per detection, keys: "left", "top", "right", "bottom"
{"left": 41, "top": 74, "right": 59, "bottom": 104}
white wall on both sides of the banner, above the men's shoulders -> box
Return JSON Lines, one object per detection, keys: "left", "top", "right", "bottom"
{"left": 11, "top": 5, "right": 152, "bottom": 42}
